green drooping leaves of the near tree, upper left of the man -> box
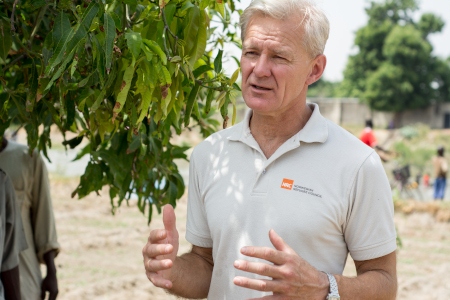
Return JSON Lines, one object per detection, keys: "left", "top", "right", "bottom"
{"left": 0, "top": 0, "right": 243, "bottom": 222}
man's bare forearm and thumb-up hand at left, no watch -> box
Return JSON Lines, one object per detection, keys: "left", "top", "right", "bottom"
{"left": 142, "top": 205, "right": 214, "bottom": 299}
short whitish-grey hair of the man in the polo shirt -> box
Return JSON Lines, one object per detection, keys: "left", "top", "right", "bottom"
{"left": 240, "top": 0, "right": 330, "bottom": 57}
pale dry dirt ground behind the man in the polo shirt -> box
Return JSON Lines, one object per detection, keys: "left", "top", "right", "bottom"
{"left": 46, "top": 176, "right": 450, "bottom": 300}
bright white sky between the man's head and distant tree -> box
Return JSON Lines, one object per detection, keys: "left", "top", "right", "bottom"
{"left": 227, "top": 0, "right": 450, "bottom": 81}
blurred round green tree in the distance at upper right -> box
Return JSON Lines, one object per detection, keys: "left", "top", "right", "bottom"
{"left": 339, "top": 0, "right": 450, "bottom": 112}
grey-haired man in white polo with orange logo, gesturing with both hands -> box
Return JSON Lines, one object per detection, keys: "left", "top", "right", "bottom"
{"left": 143, "top": 0, "right": 397, "bottom": 300}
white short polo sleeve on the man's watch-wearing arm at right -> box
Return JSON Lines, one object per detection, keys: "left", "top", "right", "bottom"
{"left": 344, "top": 152, "right": 397, "bottom": 261}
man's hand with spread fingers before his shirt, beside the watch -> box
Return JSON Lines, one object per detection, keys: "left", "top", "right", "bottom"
{"left": 233, "top": 230, "right": 329, "bottom": 300}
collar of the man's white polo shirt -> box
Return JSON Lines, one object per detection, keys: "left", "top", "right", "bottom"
{"left": 228, "top": 103, "right": 328, "bottom": 143}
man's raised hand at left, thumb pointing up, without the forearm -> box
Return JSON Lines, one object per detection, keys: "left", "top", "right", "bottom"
{"left": 142, "top": 205, "right": 179, "bottom": 289}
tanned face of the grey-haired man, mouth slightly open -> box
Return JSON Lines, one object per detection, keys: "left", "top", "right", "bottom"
{"left": 241, "top": 15, "right": 325, "bottom": 116}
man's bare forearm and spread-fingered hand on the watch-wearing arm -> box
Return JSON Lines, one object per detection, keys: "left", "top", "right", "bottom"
{"left": 234, "top": 230, "right": 397, "bottom": 300}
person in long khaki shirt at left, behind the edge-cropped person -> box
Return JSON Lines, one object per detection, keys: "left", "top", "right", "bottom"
{"left": 0, "top": 137, "right": 60, "bottom": 300}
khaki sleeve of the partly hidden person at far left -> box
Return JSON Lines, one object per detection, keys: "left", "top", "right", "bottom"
{"left": 31, "top": 151, "right": 60, "bottom": 263}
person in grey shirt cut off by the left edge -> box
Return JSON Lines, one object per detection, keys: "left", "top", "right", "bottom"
{"left": 0, "top": 169, "right": 27, "bottom": 300}
